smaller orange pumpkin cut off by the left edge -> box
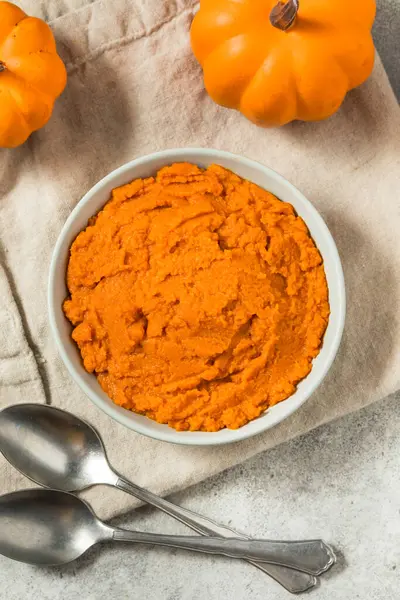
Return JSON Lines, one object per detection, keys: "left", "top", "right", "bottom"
{"left": 0, "top": 2, "right": 67, "bottom": 148}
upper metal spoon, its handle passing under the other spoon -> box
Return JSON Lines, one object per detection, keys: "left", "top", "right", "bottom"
{"left": 0, "top": 404, "right": 333, "bottom": 593}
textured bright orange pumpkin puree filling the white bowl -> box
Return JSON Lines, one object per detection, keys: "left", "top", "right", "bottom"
{"left": 64, "top": 163, "right": 329, "bottom": 431}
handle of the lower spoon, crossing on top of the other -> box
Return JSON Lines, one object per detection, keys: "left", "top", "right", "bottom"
{"left": 113, "top": 529, "right": 334, "bottom": 575}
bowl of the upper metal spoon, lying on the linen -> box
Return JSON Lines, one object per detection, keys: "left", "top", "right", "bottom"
{"left": 0, "top": 404, "right": 118, "bottom": 492}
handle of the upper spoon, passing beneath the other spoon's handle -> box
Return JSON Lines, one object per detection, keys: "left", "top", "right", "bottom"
{"left": 116, "top": 476, "right": 317, "bottom": 594}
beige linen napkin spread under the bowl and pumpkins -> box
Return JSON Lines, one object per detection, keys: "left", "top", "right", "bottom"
{"left": 0, "top": 0, "right": 400, "bottom": 517}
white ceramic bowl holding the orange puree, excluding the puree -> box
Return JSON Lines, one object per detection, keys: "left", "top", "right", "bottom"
{"left": 48, "top": 148, "right": 346, "bottom": 446}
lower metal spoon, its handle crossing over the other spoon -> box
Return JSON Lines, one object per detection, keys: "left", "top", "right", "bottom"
{"left": 0, "top": 489, "right": 331, "bottom": 575}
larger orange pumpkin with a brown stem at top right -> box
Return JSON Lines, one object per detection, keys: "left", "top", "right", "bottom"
{"left": 191, "top": 0, "right": 375, "bottom": 127}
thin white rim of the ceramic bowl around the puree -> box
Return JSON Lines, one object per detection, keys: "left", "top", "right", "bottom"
{"left": 47, "top": 147, "right": 346, "bottom": 446}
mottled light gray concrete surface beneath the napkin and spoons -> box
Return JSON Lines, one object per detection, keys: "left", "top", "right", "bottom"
{"left": 0, "top": 0, "right": 400, "bottom": 600}
